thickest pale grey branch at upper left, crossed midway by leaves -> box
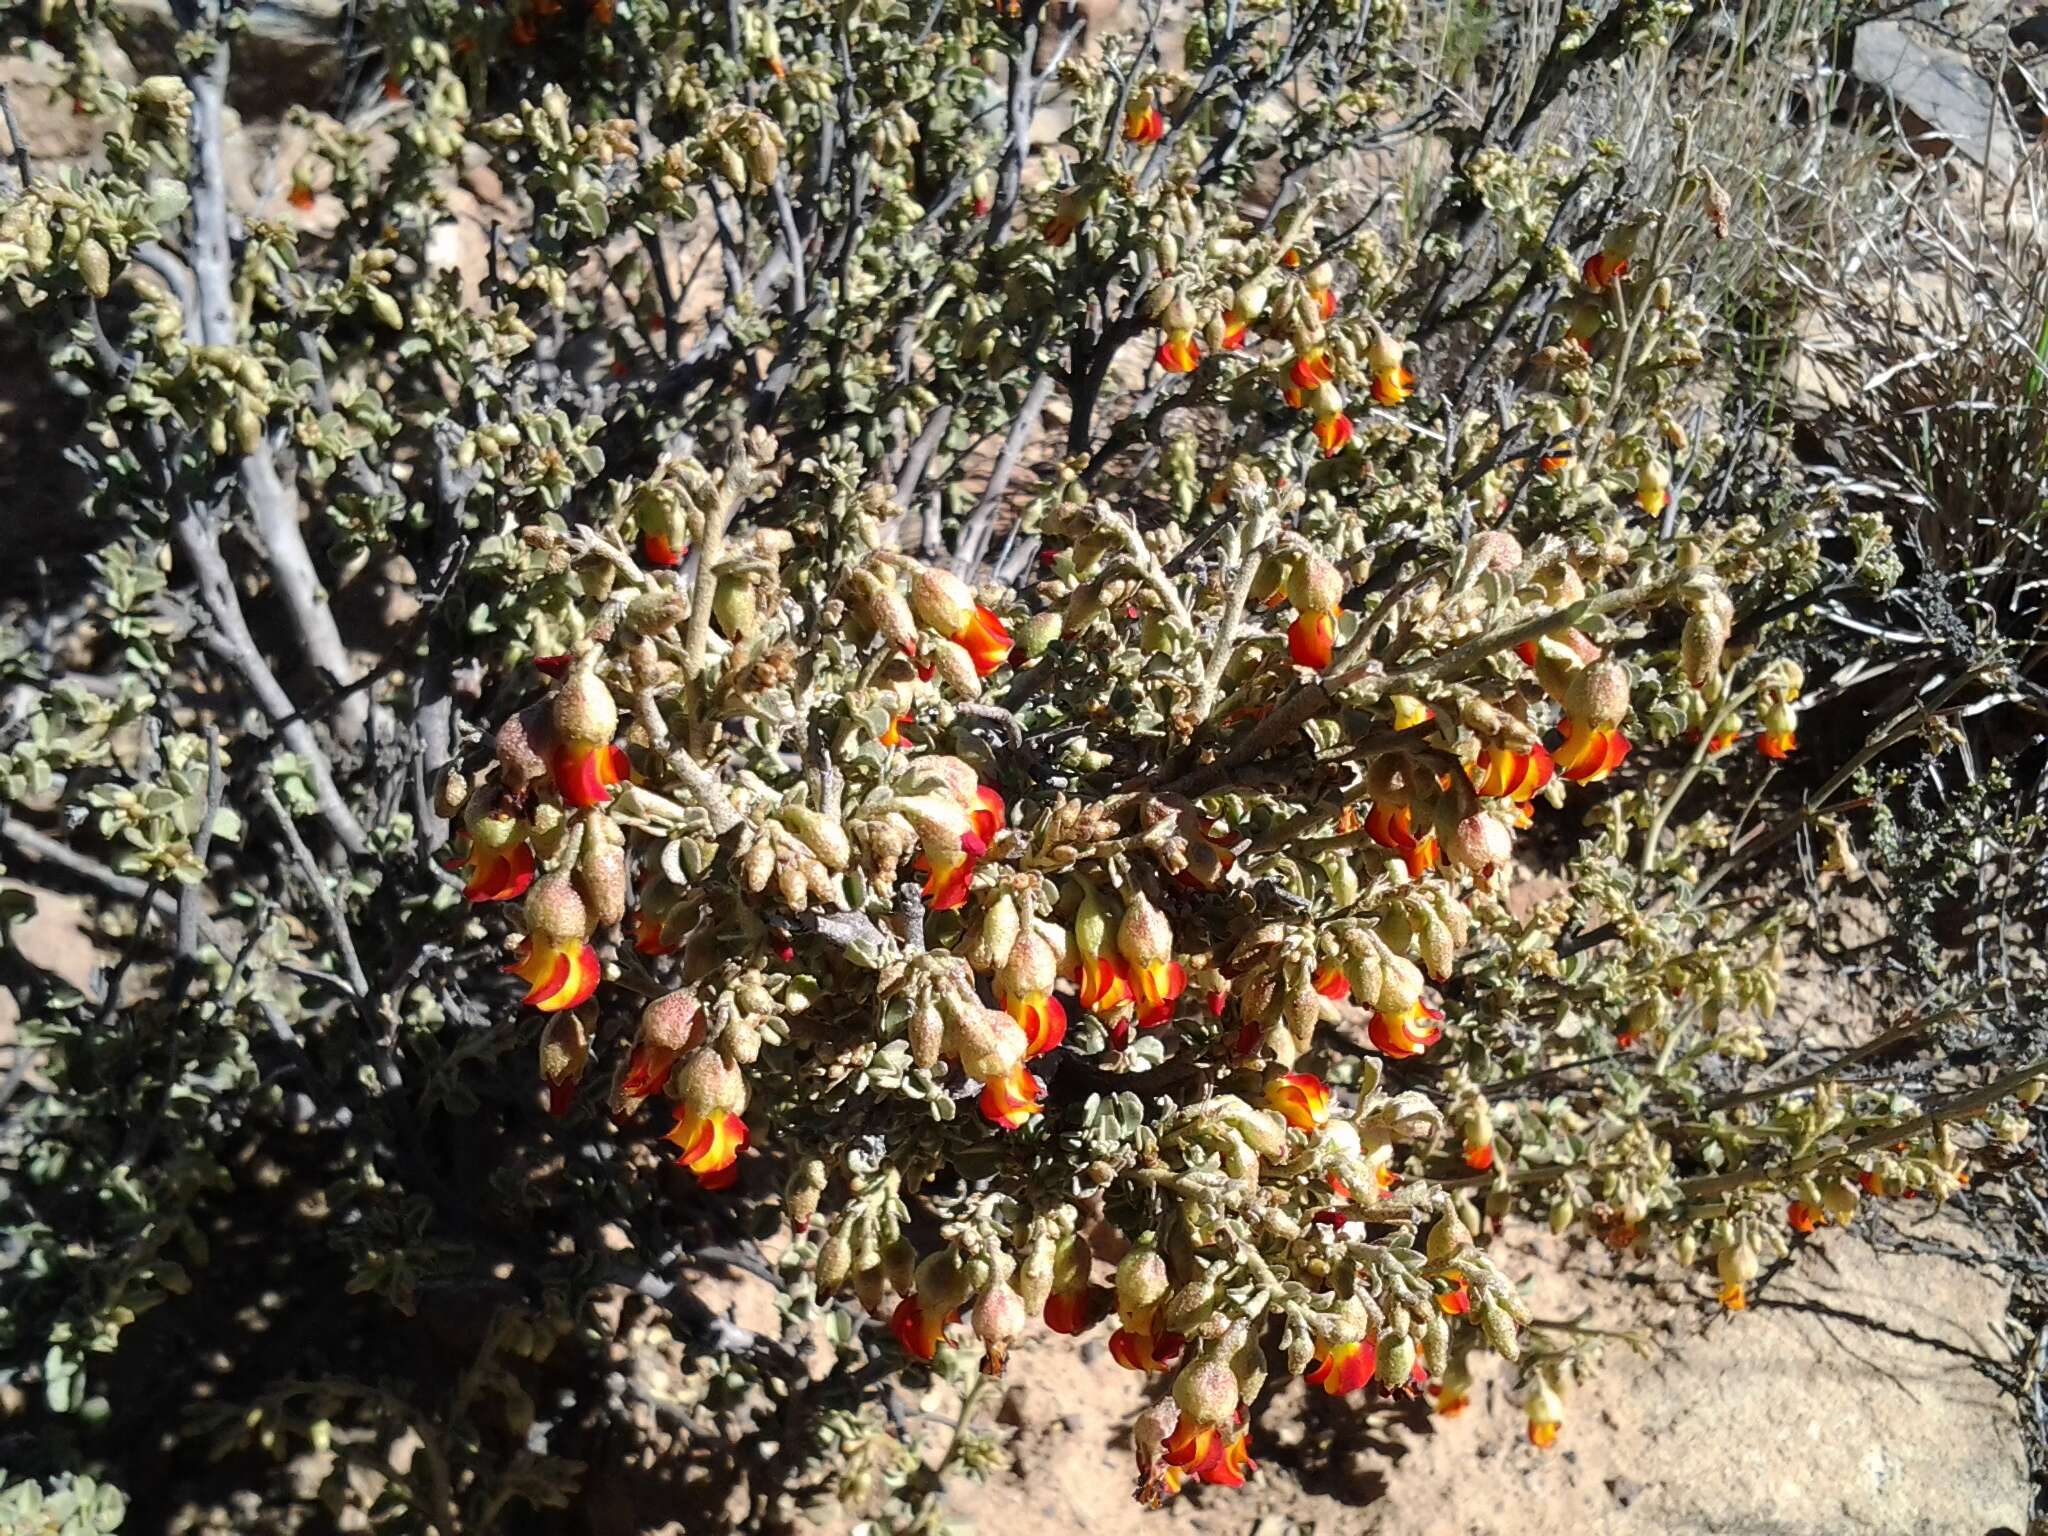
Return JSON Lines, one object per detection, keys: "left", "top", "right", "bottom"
{"left": 186, "top": 35, "right": 369, "bottom": 741}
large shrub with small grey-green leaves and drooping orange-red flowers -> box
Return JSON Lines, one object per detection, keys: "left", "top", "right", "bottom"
{"left": 0, "top": 0, "right": 2040, "bottom": 1530}
